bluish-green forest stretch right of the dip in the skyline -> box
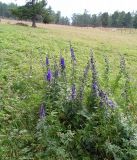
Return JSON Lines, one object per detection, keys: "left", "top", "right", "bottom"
{"left": 72, "top": 10, "right": 137, "bottom": 28}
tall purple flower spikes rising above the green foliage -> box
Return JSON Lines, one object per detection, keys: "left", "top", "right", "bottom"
{"left": 39, "top": 46, "right": 117, "bottom": 118}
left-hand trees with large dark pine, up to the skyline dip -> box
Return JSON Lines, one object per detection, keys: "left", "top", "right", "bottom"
{"left": 0, "top": 0, "right": 70, "bottom": 26}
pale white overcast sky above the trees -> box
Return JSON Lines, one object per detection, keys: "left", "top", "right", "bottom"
{"left": 0, "top": 0, "right": 137, "bottom": 17}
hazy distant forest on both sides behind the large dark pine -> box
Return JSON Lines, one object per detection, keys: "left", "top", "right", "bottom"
{"left": 0, "top": 2, "right": 137, "bottom": 28}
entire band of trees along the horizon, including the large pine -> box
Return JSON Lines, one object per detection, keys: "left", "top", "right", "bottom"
{"left": 0, "top": 0, "right": 137, "bottom": 28}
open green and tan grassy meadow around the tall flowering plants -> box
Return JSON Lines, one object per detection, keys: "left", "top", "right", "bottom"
{"left": 0, "top": 24, "right": 137, "bottom": 160}
